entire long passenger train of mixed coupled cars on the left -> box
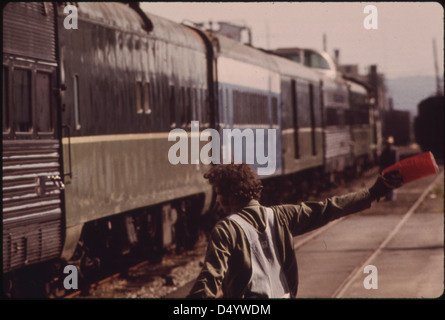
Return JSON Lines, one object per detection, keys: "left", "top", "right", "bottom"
{"left": 2, "top": 2, "right": 380, "bottom": 296}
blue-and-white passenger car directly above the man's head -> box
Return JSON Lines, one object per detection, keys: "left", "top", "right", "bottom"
{"left": 209, "top": 34, "right": 282, "bottom": 178}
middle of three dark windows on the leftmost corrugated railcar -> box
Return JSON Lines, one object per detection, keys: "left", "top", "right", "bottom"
{"left": 12, "top": 69, "right": 32, "bottom": 132}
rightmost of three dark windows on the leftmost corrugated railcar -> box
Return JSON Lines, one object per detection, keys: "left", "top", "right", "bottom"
{"left": 35, "top": 72, "right": 53, "bottom": 132}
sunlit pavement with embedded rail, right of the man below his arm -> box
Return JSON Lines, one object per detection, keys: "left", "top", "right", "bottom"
{"left": 294, "top": 167, "right": 444, "bottom": 298}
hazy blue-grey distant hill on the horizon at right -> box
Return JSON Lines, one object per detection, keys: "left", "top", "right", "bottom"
{"left": 386, "top": 76, "right": 436, "bottom": 117}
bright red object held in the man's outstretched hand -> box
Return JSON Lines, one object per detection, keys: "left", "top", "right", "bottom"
{"left": 382, "top": 151, "right": 439, "bottom": 183}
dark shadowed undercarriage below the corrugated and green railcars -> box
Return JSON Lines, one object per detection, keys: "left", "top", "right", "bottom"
{"left": 3, "top": 195, "right": 207, "bottom": 298}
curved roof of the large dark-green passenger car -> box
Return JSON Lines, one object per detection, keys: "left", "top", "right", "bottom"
{"left": 77, "top": 2, "right": 204, "bottom": 51}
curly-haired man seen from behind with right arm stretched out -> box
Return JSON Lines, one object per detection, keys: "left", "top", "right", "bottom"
{"left": 188, "top": 164, "right": 403, "bottom": 298}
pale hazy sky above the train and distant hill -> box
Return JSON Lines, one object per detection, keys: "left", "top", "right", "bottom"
{"left": 142, "top": 2, "right": 444, "bottom": 79}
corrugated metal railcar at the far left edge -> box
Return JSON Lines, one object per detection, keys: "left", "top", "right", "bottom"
{"left": 2, "top": 2, "right": 63, "bottom": 273}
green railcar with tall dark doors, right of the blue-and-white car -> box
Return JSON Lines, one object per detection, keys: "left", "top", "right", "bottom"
{"left": 268, "top": 56, "right": 323, "bottom": 175}
